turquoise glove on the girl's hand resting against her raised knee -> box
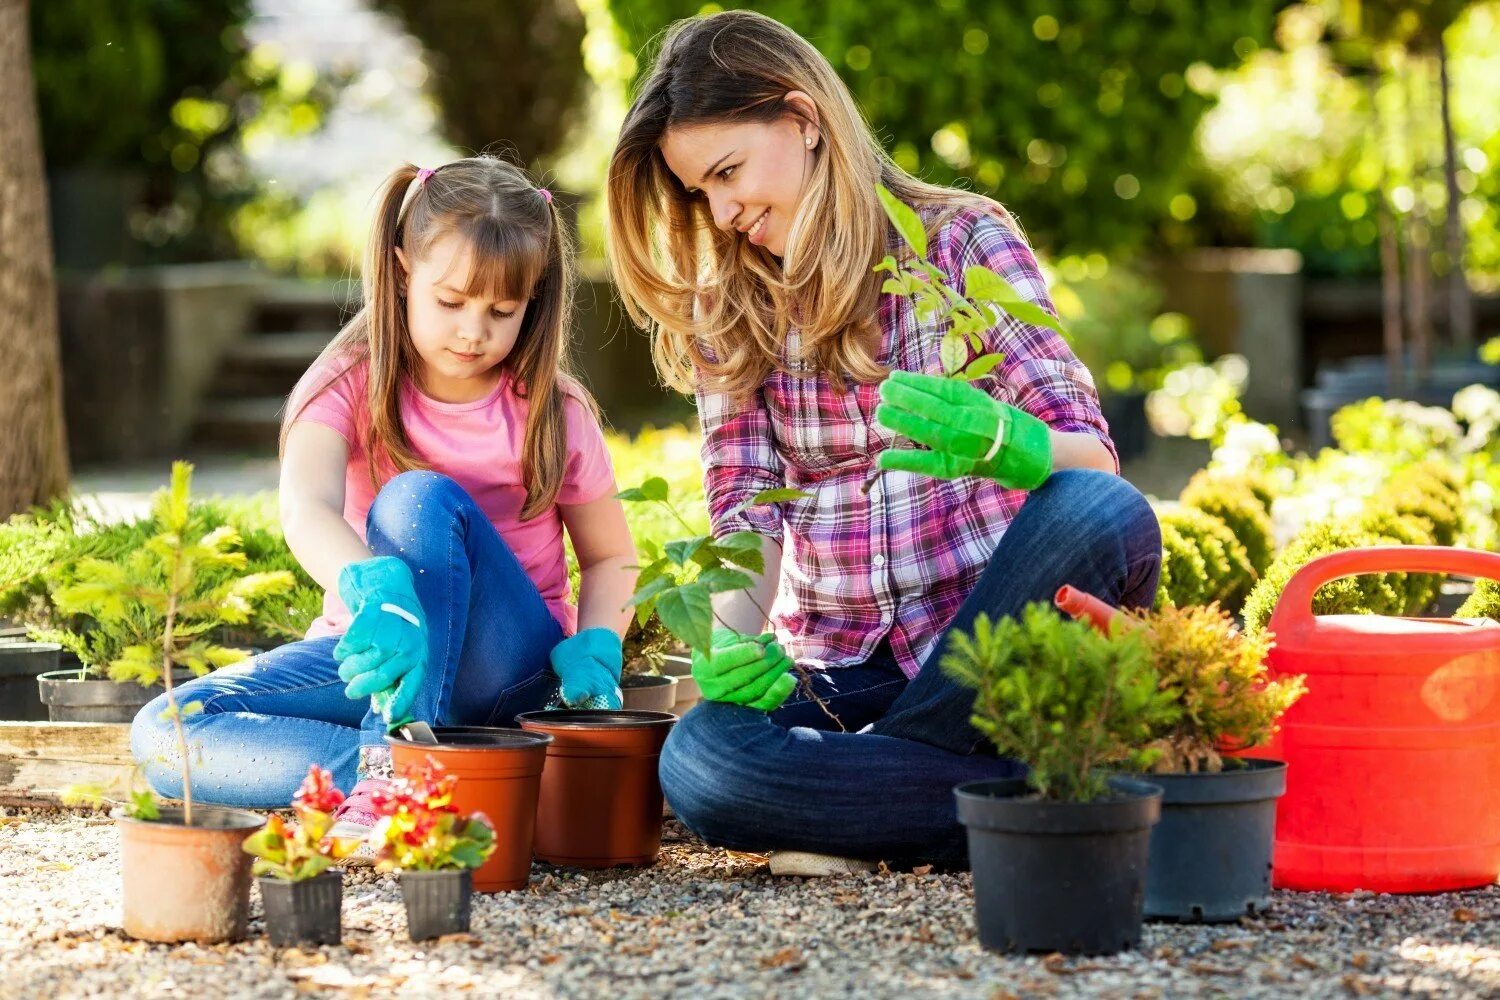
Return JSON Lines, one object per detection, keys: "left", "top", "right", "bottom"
{"left": 333, "top": 556, "right": 428, "bottom": 724}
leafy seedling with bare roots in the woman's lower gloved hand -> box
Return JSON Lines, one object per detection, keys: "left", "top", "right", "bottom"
{"left": 617, "top": 477, "right": 843, "bottom": 729}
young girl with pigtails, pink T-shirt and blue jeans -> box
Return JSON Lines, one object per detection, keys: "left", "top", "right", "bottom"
{"left": 132, "top": 156, "right": 635, "bottom": 835}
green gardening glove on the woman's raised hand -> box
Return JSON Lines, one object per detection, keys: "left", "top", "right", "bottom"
{"left": 875, "top": 370, "right": 1052, "bottom": 490}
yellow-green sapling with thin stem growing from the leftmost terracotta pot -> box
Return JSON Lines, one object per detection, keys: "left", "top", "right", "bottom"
{"left": 56, "top": 462, "right": 294, "bottom": 826}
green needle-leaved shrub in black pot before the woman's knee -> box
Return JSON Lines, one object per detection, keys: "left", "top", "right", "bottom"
{"left": 942, "top": 604, "right": 1179, "bottom": 954}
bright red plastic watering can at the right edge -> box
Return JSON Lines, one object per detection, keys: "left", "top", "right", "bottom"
{"left": 1254, "top": 546, "right": 1500, "bottom": 892}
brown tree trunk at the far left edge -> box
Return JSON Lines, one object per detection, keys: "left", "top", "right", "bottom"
{"left": 0, "top": 0, "right": 68, "bottom": 517}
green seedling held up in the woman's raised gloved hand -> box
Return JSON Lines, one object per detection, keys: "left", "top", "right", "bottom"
{"left": 861, "top": 184, "right": 1067, "bottom": 492}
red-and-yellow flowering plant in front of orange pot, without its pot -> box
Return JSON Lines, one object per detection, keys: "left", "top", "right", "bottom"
{"left": 371, "top": 757, "right": 495, "bottom": 871}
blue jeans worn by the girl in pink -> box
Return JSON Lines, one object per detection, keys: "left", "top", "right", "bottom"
{"left": 131, "top": 472, "right": 563, "bottom": 808}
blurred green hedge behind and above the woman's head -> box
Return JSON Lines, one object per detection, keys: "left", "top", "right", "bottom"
{"left": 612, "top": 0, "right": 1281, "bottom": 252}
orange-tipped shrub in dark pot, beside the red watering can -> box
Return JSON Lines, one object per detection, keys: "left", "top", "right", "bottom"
{"left": 1124, "top": 604, "right": 1307, "bottom": 921}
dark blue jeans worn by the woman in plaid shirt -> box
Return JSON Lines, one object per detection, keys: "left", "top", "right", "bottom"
{"left": 662, "top": 469, "right": 1161, "bottom": 864}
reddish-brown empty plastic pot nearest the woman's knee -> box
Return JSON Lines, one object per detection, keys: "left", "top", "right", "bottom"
{"left": 516, "top": 709, "right": 677, "bottom": 868}
